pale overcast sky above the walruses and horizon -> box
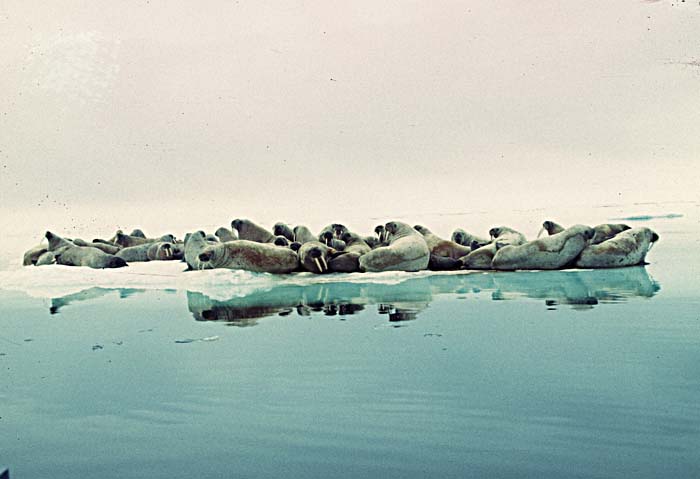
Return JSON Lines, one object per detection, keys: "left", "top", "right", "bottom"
{"left": 0, "top": 0, "right": 700, "bottom": 227}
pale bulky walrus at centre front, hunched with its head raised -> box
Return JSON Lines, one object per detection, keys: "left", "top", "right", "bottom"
{"left": 360, "top": 221, "right": 430, "bottom": 272}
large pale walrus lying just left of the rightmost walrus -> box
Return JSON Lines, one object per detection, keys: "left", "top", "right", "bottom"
{"left": 491, "top": 225, "right": 595, "bottom": 271}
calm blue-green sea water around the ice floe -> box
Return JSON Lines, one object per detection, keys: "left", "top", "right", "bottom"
{"left": 0, "top": 204, "right": 700, "bottom": 478}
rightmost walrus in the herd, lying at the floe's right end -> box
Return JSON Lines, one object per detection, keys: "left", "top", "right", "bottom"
{"left": 576, "top": 227, "right": 659, "bottom": 268}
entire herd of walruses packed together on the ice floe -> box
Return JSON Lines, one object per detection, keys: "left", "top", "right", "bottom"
{"left": 23, "top": 219, "right": 659, "bottom": 274}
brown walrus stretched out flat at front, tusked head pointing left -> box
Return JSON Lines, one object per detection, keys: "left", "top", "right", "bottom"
{"left": 197, "top": 240, "right": 299, "bottom": 274}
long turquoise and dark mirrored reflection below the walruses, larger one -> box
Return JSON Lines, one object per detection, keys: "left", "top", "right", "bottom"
{"left": 187, "top": 267, "right": 659, "bottom": 326}
